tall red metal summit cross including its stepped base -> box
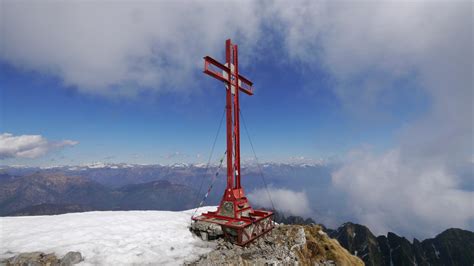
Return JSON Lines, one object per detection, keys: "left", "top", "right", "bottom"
{"left": 193, "top": 39, "right": 273, "bottom": 245}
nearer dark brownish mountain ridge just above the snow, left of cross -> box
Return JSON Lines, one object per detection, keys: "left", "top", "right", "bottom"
{"left": 0, "top": 173, "right": 196, "bottom": 216}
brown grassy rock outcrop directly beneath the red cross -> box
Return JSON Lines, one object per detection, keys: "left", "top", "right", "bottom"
{"left": 190, "top": 225, "right": 364, "bottom": 265}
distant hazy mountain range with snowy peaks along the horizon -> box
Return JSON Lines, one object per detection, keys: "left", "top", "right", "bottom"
{"left": 0, "top": 162, "right": 332, "bottom": 214}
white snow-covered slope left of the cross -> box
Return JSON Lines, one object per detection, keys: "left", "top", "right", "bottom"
{"left": 0, "top": 207, "right": 216, "bottom": 265}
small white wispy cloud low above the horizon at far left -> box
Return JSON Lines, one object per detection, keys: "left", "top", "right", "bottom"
{"left": 0, "top": 133, "right": 78, "bottom": 159}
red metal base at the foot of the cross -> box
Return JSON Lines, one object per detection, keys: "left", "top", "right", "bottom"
{"left": 192, "top": 189, "right": 274, "bottom": 246}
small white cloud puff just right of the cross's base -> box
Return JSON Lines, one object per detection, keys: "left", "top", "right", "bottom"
{"left": 247, "top": 188, "right": 312, "bottom": 217}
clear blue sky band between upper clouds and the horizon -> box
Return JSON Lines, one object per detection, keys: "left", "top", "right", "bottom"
{"left": 0, "top": 45, "right": 424, "bottom": 165}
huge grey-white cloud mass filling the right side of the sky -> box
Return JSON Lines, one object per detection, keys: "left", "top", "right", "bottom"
{"left": 290, "top": 2, "right": 474, "bottom": 237}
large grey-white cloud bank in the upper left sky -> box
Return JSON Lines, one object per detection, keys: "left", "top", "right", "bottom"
{"left": 0, "top": 0, "right": 260, "bottom": 96}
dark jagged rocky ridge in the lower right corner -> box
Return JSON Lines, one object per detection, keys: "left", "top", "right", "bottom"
{"left": 329, "top": 223, "right": 474, "bottom": 266}
